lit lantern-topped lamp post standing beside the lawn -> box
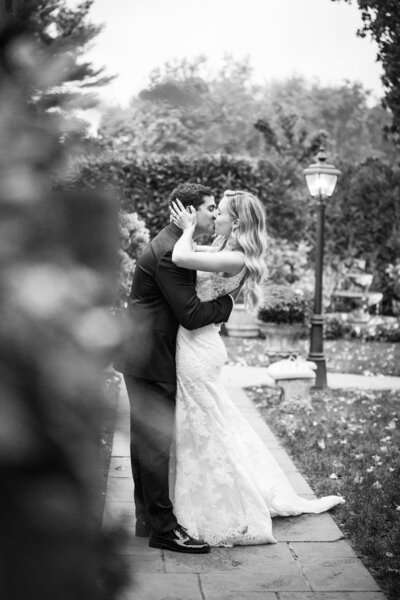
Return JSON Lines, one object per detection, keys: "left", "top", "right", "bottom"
{"left": 303, "top": 146, "right": 340, "bottom": 388}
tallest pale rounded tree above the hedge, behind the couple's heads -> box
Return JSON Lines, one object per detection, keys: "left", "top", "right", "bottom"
{"left": 100, "top": 56, "right": 261, "bottom": 157}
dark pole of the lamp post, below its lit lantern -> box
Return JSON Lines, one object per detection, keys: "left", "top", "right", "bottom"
{"left": 308, "top": 194, "right": 326, "bottom": 388}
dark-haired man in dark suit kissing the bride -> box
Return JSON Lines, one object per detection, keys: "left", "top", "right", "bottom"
{"left": 120, "top": 183, "right": 233, "bottom": 554}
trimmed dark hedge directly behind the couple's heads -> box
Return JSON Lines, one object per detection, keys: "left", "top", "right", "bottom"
{"left": 74, "top": 155, "right": 311, "bottom": 242}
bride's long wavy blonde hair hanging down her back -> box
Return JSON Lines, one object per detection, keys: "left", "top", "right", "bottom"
{"left": 223, "top": 190, "right": 267, "bottom": 313}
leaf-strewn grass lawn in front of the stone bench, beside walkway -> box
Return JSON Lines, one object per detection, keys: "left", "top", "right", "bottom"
{"left": 247, "top": 384, "right": 400, "bottom": 600}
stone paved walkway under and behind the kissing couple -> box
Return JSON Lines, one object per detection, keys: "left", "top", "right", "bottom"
{"left": 104, "top": 367, "right": 390, "bottom": 600}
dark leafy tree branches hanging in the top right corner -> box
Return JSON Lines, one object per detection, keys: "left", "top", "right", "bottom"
{"left": 332, "top": 0, "right": 400, "bottom": 144}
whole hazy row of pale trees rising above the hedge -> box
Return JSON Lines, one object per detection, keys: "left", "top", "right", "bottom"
{"left": 100, "top": 56, "right": 393, "bottom": 162}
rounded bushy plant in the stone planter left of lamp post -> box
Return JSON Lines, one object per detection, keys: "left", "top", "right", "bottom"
{"left": 258, "top": 284, "right": 311, "bottom": 324}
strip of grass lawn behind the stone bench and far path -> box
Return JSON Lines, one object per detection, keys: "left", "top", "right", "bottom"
{"left": 223, "top": 337, "right": 400, "bottom": 376}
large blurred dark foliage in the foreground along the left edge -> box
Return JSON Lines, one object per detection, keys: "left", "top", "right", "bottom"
{"left": 0, "top": 3, "right": 128, "bottom": 600}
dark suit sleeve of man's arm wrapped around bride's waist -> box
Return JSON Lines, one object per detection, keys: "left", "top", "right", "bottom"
{"left": 156, "top": 251, "right": 233, "bottom": 330}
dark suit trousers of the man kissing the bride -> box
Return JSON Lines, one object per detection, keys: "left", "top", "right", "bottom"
{"left": 124, "top": 374, "right": 177, "bottom": 535}
